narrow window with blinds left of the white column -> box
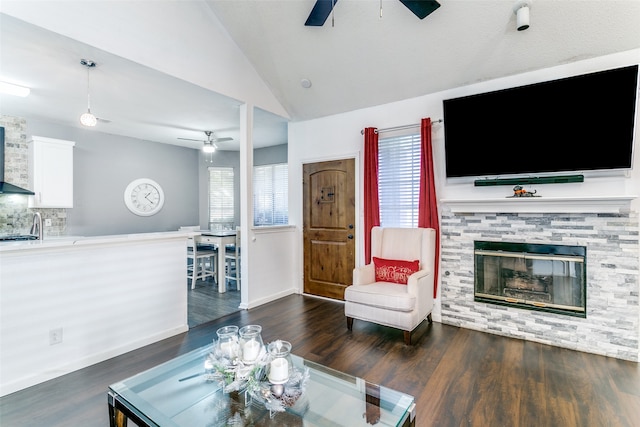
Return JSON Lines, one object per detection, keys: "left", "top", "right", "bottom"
{"left": 209, "top": 167, "right": 235, "bottom": 229}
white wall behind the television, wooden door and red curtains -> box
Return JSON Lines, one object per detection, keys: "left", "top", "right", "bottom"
{"left": 289, "top": 49, "right": 640, "bottom": 320}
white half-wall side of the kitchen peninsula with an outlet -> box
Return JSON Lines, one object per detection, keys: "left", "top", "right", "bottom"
{"left": 0, "top": 231, "right": 192, "bottom": 396}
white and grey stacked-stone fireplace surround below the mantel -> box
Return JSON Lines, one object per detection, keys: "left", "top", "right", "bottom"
{"left": 440, "top": 200, "right": 640, "bottom": 362}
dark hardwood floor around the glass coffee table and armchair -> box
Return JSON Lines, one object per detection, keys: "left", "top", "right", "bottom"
{"left": 0, "top": 295, "right": 640, "bottom": 427}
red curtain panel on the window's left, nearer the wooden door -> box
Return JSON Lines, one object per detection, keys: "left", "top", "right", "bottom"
{"left": 363, "top": 128, "right": 380, "bottom": 264}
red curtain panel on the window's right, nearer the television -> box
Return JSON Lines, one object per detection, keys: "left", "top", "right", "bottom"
{"left": 418, "top": 118, "right": 440, "bottom": 298}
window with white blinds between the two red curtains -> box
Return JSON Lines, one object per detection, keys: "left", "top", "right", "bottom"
{"left": 378, "top": 134, "right": 420, "bottom": 227}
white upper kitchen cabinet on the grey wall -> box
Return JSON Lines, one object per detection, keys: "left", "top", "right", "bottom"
{"left": 29, "top": 136, "right": 75, "bottom": 208}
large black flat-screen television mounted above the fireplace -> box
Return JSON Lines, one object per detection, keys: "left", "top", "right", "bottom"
{"left": 443, "top": 65, "right": 638, "bottom": 177}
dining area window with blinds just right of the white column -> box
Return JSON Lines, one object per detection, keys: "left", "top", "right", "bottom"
{"left": 253, "top": 163, "right": 289, "bottom": 226}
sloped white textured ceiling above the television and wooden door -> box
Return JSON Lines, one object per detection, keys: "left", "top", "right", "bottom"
{"left": 207, "top": 0, "right": 640, "bottom": 120}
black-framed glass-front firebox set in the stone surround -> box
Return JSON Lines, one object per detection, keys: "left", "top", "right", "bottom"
{"left": 474, "top": 241, "right": 587, "bottom": 317}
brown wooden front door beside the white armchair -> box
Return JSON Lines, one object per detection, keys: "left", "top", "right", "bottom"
{"left": 303, "top": 159, "right": 356, "bottom": 300}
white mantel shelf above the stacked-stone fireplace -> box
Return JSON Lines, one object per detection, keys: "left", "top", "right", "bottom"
{"left": 440, "top": 195, "right": 638, "bottom": 213}
